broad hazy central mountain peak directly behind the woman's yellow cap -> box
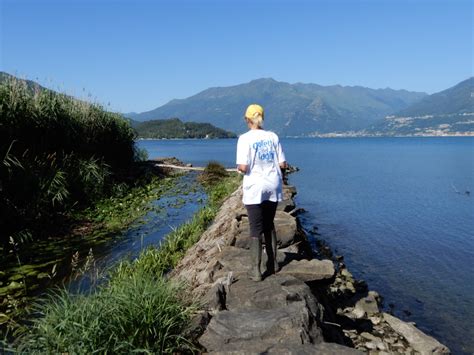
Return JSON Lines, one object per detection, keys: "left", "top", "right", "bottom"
{"left": 129, "top": 79, "right": 426, "bottom": 135}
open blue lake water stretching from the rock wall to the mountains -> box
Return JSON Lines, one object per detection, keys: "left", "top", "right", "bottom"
{"left": 138, "top": 137, "right": 474, "bottom": 354}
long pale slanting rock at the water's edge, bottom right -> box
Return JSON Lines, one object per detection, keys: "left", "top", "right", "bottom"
{"left": 383, "top": 313, "right": 451, "bottom": 355}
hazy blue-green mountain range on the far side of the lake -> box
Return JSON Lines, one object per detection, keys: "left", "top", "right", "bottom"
{"left": 0, "top": 72, "right": 474, "bottom": 137}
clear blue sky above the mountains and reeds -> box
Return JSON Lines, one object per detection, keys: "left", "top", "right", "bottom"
{"left": 0, "top": 0, "right": 473, "bottom": 112}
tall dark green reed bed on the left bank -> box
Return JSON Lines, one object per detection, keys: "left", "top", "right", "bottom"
{"left": 0, "top": 77, "right": 136, "bottom": 246}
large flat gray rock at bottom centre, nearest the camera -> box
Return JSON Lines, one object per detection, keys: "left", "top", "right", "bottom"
{"left": 199, "top": 302, "right": 321, "bottom": 353}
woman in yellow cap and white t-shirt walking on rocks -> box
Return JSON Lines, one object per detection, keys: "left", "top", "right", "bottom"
{"left": 237, "top": 104, "right": 287, "bottom": 281}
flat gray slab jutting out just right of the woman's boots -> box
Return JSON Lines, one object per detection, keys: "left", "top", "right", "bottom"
{"left": 280, "top": 259, "right": 335, "bottom": 282}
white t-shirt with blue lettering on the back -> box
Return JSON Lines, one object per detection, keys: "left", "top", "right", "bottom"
{"left": 236, "top": 129, "right": 286, "bottom": 205}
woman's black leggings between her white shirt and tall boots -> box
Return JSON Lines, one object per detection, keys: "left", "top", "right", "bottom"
{"left": 245, "top": 201, "right": 278, "bottom": 239}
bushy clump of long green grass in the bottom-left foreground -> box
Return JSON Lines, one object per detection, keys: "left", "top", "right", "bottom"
{"left": 16, "top": 274, "right": 196, "bottom": 354}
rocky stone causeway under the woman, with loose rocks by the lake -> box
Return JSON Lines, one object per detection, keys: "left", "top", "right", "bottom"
{"left": 171, "top": 182, "right": 450, "bottom": 355}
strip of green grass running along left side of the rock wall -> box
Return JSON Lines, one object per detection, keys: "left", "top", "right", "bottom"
{"left": 8, "top": 175, "right": 240, "bottom": 354}
